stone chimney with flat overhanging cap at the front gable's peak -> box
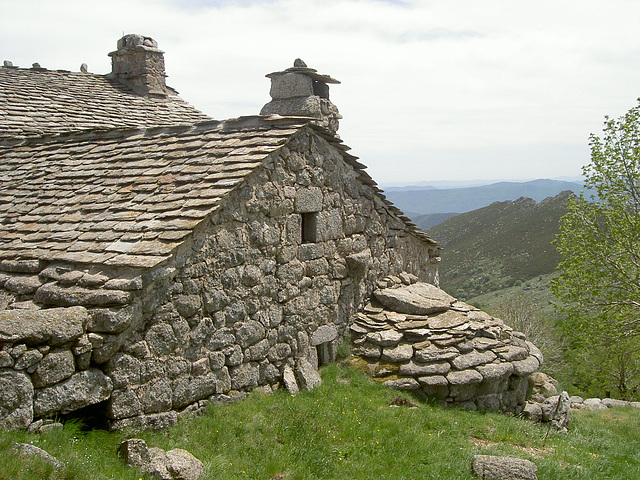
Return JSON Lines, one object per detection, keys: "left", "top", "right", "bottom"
{"left": 260, "top": 58, "right": 342, "bottom": 134}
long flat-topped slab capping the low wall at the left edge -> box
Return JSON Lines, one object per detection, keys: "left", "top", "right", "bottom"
{"left": 0, "top": 307, "right": 89, "bottom": 346}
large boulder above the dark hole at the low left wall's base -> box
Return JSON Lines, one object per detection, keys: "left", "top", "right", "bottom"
{"left": 33, "top": 368, "right": 113, "bottom": 417}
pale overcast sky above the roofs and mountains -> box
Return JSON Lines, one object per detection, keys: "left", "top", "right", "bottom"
{"left": 5, "top": 0, "right": 640, "bottom": 185}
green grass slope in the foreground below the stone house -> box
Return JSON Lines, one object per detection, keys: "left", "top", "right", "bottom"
{"left": 0, "top": 365, "right": 640, "bottom": 480}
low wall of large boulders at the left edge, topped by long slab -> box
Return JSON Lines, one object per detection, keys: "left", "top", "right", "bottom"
{"left": 0, "top": 306, "right": 113, "bottom": 429}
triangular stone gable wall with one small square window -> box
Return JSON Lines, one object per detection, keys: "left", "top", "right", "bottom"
{"left": 101, "top": 129, "right": 437, "bottom": 427}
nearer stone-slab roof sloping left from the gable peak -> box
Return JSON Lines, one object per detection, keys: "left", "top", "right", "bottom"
{"left": 0, "top": 117, "right": 436, "bottom": 268}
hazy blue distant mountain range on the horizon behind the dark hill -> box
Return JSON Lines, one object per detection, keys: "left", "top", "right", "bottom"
{"left": 385, "top": 179, "right": 583, "bottom": 219}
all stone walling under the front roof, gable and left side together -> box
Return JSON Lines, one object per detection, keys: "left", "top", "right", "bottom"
{"left": 0, "top": 130, "right": 438, "bottom": 428}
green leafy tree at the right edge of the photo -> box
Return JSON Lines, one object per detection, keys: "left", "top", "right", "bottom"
{"left": 552, "top": 99, "right": 640, "bottom": 397}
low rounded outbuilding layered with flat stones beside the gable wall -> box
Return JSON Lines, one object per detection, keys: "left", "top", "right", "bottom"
{"left": 351, "top": 274, "right": 543, "bottom": 413}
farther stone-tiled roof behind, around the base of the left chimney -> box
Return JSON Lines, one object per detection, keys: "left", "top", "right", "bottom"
{"left": 0, "top": 66, "right": 211, "bottom": 138}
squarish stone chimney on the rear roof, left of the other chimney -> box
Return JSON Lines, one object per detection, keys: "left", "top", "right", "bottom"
{"left": 109, "top": 34, "right": 167, "bottom": 96}
